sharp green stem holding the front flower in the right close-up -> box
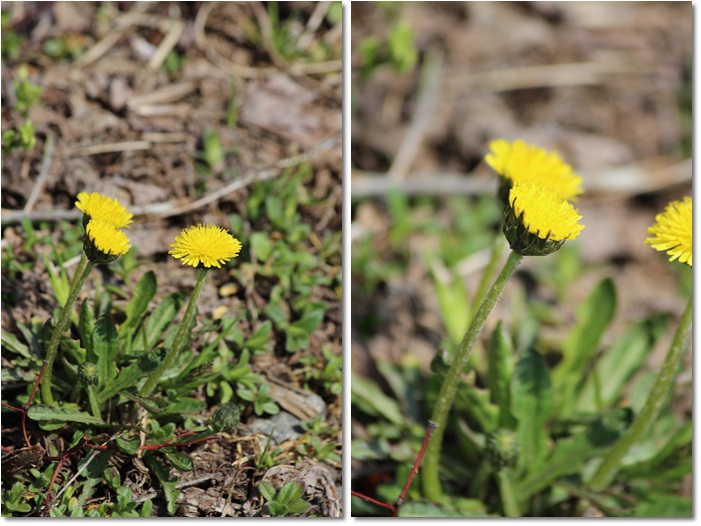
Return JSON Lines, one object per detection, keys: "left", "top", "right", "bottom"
{"left": 422, "top": 252, "right": 523, "bottom": 501}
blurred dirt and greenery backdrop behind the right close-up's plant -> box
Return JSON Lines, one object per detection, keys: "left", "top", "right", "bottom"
{"left": 349, "top": 2, "right": 692, "bottom": 513}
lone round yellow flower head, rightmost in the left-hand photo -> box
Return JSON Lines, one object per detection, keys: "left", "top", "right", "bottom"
{"left": 168, "top": 225, "right": 241, "bottom": 268}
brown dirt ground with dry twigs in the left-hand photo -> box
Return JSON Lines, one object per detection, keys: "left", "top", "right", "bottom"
{"left": 2, "top": 2, "right": 342, "bottom": 516}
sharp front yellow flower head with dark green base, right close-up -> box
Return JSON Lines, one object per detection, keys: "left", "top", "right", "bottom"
{"left": 504, "top": 181, "right": 584, "bottom": 256}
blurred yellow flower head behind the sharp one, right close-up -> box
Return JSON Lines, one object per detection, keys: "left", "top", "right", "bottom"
{"left": 484, "top": 139, "right": 583, "bottom": 201}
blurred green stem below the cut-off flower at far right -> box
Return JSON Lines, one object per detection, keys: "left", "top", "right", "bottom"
{"left": 589, "top": 298, "right": 692, "bottom": 492}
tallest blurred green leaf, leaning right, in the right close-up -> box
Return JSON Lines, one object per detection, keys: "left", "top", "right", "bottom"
{"left": 553, "top": 278, "right": 616, "bottom": 416}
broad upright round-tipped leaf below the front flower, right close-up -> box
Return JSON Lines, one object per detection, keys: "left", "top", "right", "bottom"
{"left": 511, "top": 349, "right": 553, "bottom": 467}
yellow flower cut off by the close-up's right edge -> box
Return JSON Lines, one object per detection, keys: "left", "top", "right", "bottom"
{"left": 645, "top": 197, "right": 692, "bottom": 266}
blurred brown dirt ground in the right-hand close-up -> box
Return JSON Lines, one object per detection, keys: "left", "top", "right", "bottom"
{"left": 351, "top": 2, "right": 692, "bottom": 508}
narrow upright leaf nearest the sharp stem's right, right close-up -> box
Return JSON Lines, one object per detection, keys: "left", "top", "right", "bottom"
{"left": 487, "top": 321, "right": 516, "bottom": 429}
